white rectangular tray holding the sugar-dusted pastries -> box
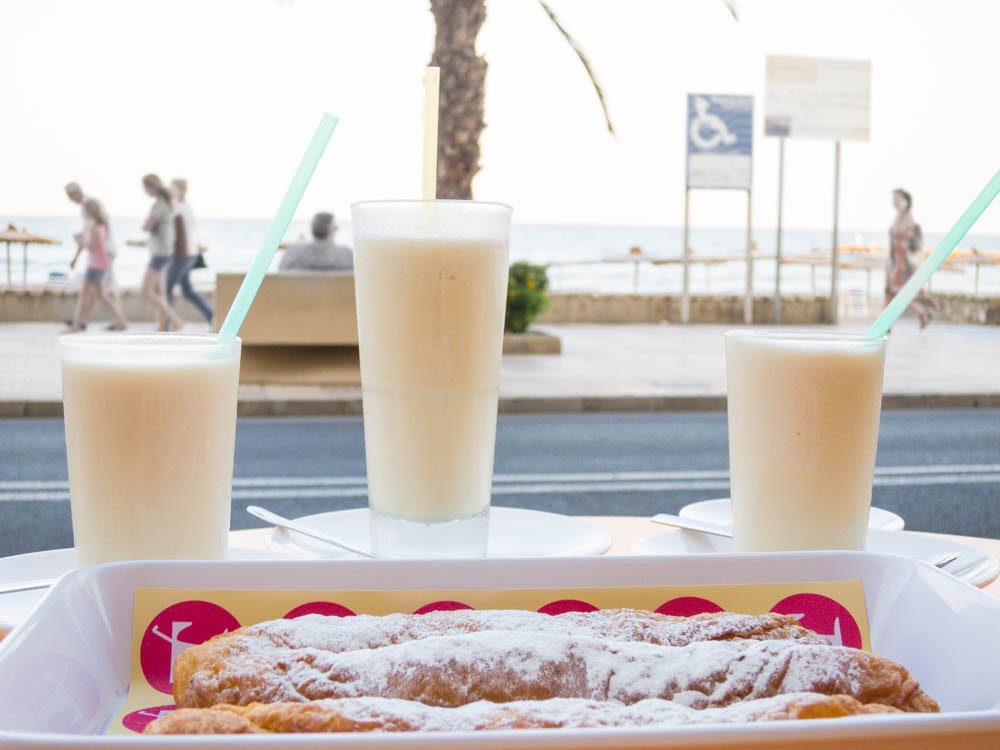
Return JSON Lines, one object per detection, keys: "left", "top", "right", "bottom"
{"left": 0, "top": 552, "right": 1000, "bottom": 750}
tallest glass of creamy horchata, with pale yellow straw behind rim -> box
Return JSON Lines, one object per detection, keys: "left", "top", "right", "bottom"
{"left": 351, "top": 201, "right": 511, "bottom": 557}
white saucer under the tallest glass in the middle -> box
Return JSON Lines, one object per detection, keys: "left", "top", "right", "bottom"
{"left": 266, "top": 506, "right": 611, "bottom": 558}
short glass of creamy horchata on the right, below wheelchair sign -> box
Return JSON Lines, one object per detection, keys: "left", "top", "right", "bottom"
{"left": 726, "top": 330, "right": 886, "bottom": 552}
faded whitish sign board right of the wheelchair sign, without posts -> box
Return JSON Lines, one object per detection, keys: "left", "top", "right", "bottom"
{"left": 764, "top": 55, "right": 872, "bottom": 141}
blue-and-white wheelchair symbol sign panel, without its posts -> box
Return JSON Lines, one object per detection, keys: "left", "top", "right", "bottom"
{"left": 687, "top": 94, "right": 753, "bottom": 190}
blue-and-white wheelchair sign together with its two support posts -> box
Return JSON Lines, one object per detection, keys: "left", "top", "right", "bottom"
{"left": 681, "top": 94, "right": 753, "bottom": 323}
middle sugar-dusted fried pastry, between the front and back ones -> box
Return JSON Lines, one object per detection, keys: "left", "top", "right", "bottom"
{"left": 174, "top": 632, "right": 937, "bottom": 711}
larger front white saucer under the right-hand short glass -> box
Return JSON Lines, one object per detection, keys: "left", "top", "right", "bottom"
{"left": 632, "top": 529, "right": 1000, "bottom": 586}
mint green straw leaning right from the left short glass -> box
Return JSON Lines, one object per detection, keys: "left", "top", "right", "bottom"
{"left": 219, "top": 112, "right": 339, "bottom": 340}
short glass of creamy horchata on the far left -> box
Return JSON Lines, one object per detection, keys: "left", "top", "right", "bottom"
{"left": 59, "top": 334, "right": 240, "bottom": 565}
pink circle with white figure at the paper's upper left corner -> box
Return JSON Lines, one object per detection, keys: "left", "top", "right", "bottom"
{"left": 139, "top": 599, "right": 240, "bottom": 695}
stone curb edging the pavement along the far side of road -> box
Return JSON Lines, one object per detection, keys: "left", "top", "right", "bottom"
{"left": 0, "top": 393, "right": 1000, "bottom": 419}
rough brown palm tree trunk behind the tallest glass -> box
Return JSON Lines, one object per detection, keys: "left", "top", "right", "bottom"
{"left": 431, "top": 0, "right": 486, "bottom": 200}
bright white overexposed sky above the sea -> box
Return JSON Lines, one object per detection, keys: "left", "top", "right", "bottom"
{"left": 0, "top": 0, "right": 1000, "bottom": 233}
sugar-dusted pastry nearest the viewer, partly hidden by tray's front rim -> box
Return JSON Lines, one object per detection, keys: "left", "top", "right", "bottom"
{"left": 145, "top": 693, "right": 897, "bottom": 734}
